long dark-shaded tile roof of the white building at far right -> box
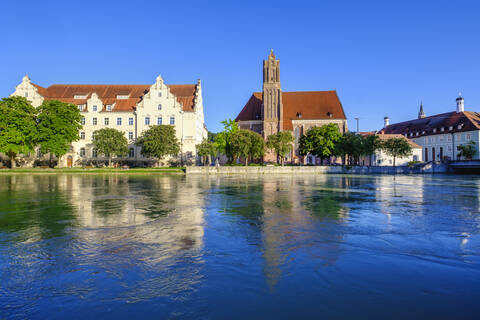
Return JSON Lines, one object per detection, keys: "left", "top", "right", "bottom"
{"left": 379, "top": 111, "right": 480, "bottom": 137}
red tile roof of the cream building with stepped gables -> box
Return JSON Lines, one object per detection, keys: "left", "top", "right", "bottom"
{"left": 33, "top": 84, "right": 197, "bottom": 112}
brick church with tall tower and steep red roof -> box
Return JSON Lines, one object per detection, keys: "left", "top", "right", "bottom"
{"left": 235, "top": 50, "right": 347, "bottom": 164}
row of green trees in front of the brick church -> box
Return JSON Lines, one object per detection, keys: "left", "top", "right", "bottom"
{"left": 197, "top": 120, "right": 412, "bottom": 165}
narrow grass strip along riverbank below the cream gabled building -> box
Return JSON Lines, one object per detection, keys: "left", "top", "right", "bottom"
{"left": 0, "top": 167, "right": 185, "bottom": 174}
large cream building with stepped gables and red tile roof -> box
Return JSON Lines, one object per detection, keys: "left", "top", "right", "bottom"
{"left": 12, "top": 76, "right": 207, "bottom": 166}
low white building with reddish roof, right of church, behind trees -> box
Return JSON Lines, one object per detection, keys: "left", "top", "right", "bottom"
{"left": 359, "top": 132, "right": 422, "bottom": 166}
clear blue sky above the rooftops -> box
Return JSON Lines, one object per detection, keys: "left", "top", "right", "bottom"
{"left": 0, "top": 0, "right": 480, "bottom": 131}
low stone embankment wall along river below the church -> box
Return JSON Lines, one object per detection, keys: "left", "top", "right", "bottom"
{"left": 187, "top": 163, "right": 448, "bottom": 175}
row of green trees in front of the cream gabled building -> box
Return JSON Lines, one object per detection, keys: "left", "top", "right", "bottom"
{"left": 0, "top": 97, "right": 180, "bottom": 168}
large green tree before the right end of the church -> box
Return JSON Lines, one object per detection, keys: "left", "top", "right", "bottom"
{"left": 299, "top": 123, "right": 342, "bottom": 162}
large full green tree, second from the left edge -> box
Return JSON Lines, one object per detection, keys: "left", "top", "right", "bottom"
{"left": 37, "top": 100, "right": 82, "bottom": 166}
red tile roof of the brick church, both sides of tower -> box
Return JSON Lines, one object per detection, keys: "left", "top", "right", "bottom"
{"left": 235, "top": 91, "right": 346, "bottom": 130}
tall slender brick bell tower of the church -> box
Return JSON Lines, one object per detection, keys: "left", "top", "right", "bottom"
{"left": 262, "top": 50, "right": 283, "bottom": 138}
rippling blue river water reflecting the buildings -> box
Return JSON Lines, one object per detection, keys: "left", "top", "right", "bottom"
{"left": 0, "top": 174, "right": 480, "bottom": 319}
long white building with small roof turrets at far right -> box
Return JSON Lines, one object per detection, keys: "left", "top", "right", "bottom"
{"left": 379, "top": 95, "right": 480, "bottom": 162}
